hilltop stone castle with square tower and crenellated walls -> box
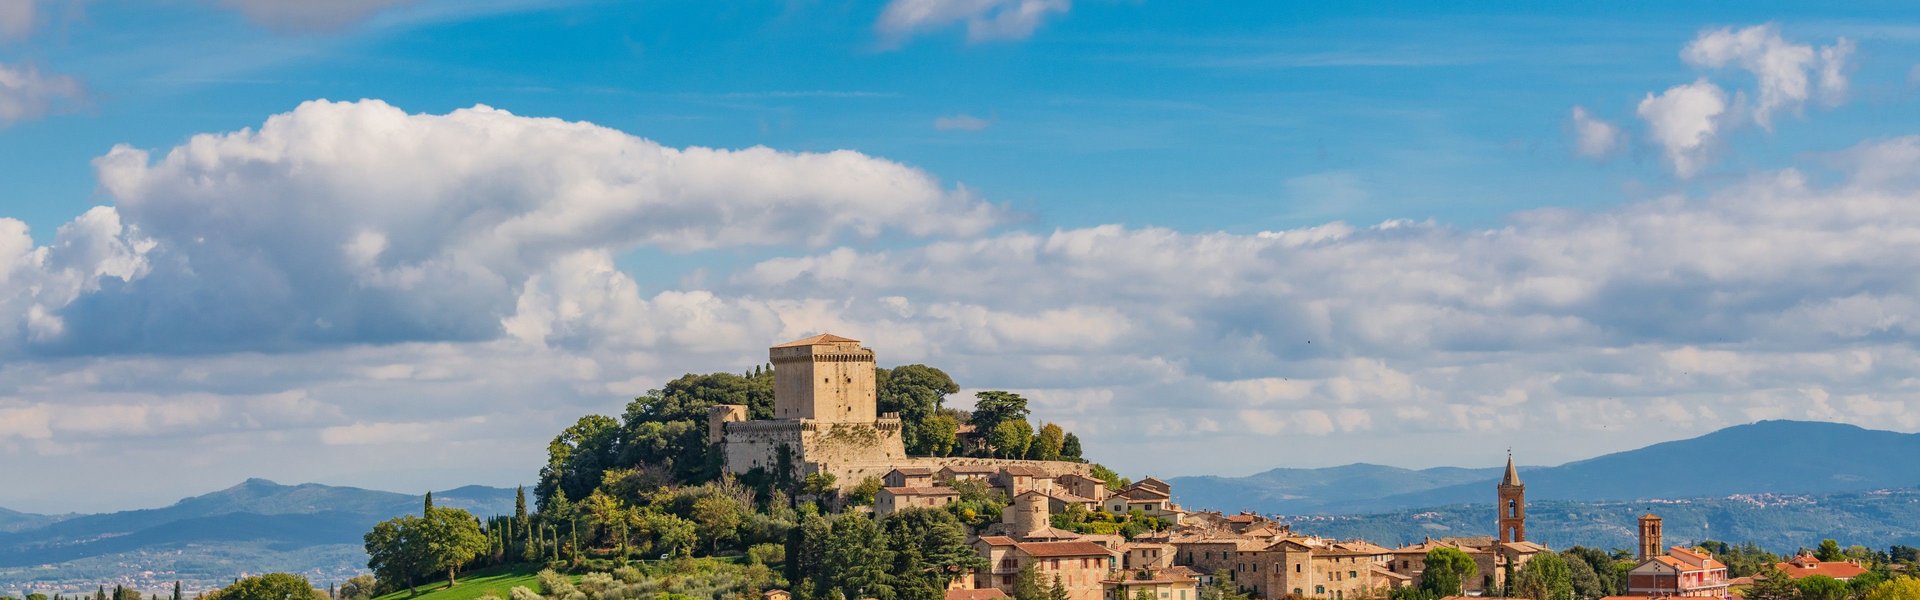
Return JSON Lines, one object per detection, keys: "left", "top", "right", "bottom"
{"left": 707, "top": 333, "right": 1091, "bottom": 488}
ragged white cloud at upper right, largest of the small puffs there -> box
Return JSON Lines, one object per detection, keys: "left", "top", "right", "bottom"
{"left": 1680, "top": 23, "right": 1853, "bottom": 129}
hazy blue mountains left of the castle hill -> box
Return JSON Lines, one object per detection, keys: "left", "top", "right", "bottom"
{"left": 0, "top": 479, "right": 515, "bottom": 596}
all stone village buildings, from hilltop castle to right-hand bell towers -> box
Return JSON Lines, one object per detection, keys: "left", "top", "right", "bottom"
{"left": 708, "top": 335, "right": 1781, "bottom": 600}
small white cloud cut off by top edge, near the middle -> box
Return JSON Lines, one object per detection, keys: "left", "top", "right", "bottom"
{"left": 874, "top": 0, "right": 1073, "bottom": 44}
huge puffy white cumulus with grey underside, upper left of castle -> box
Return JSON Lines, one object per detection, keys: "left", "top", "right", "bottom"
{"left": 0, "top": 102, "right": 1000, "bottom": 354}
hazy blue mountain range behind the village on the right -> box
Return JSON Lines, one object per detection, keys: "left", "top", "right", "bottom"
{"left": 1167, "top": 421, "right": 1920, "bottom": 515}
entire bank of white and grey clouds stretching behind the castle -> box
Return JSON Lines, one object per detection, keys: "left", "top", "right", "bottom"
{"left": 18, "top": 102, "right": 1920, "bottom": 504}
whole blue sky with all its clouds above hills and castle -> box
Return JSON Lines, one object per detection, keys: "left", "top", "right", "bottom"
{"left": 0, "top": 0, "right": 1920, "bottom": 512}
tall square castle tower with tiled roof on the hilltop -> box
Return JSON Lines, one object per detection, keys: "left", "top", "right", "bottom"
{"left": 766, "top": 333, "right": 879, "bottom": 423}
